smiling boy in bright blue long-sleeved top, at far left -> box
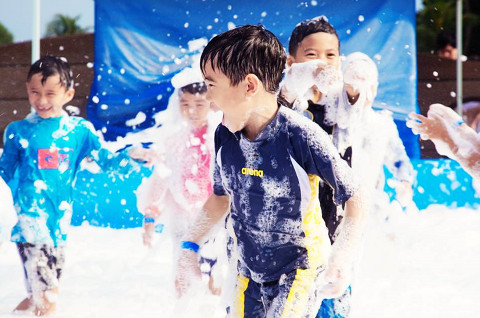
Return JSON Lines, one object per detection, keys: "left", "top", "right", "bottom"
{"left": 0, "top": 56, "right": 138, "bottom": 316}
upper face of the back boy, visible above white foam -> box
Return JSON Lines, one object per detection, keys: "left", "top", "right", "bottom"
{"left": 287, "top": 32, "right": 340, "bottom": 68}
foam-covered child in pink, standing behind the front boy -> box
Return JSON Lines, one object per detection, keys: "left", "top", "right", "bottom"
{"left": 130, "top": 68, "right": 218, "bottom": 247}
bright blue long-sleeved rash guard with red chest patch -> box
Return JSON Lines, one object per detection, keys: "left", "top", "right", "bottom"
{"left": 0, "top": 112, "right": 131, "bottom": 246}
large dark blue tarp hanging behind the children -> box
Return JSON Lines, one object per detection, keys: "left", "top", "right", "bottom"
{"left": 88, "top": 0, "right": 419, "bottom": 158}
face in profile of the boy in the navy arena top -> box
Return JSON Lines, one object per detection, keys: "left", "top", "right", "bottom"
{"left": 203, "top": 62, "right": 254, "bottom": 133}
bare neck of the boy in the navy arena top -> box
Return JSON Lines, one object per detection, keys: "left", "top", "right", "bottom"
{"left": 243, "top": 94, "right": 278, "bottom": 140}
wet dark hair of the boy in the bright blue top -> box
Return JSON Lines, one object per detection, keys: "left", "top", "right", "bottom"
{"left": 27, "top": 55, "right": 73, "bottom": 90}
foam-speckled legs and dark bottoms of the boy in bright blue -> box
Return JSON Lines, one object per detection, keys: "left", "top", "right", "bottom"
{"left": 15, "top": 243, "right": 65, "bottom": 316}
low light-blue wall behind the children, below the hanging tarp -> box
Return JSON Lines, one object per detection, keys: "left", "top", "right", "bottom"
{"left": 72, "top": 159, "right": 480, "bottom": 229}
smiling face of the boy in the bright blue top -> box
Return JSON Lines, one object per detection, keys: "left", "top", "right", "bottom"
{"left": 27, "top": 73, "right": 75, "bottom": 118}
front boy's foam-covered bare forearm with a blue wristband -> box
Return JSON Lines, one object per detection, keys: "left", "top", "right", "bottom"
{"left": 175, "top": 194, "right": 230, "bottom": 297}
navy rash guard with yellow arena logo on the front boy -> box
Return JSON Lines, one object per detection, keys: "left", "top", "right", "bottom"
{"left": 214, "top": 107, "right": 357, "bottom": 282}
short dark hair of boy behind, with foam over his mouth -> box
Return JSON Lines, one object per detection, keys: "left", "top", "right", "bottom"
{"left": 288, "top": 17, "right": 340, "bottom": 56}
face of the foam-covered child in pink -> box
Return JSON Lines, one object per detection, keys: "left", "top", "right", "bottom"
{"left": 180, "top": 92, "right": 210, "bottom": 128}
